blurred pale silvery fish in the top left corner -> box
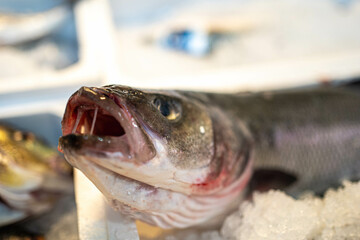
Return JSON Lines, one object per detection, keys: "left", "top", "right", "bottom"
{"left": 0, "top": 5, "right": 70, "bottom": 46}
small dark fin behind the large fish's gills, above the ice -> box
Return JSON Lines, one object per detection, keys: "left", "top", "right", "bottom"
{"left": 250, "top": 169, "right": 298, "bottom": 192}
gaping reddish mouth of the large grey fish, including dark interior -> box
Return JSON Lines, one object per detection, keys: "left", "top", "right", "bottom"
{"left": 59, "top": 87, "right": 155, "bottom": 164}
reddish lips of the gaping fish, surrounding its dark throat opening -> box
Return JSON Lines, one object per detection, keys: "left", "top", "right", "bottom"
{"left": 59, "top": 87, "right": 155, "bottom": 163}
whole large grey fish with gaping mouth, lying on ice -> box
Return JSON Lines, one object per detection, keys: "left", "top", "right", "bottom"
{"left": 59, "top": 85, "right": 360, "bottom": 229}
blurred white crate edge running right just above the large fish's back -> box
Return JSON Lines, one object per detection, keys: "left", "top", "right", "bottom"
{"left": 113, "top": 51, "right": 360, "bottom": 92}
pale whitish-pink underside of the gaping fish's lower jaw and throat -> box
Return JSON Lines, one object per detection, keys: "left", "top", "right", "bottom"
{"left": 63, "top": 152, "right": 252, "bottom": 229}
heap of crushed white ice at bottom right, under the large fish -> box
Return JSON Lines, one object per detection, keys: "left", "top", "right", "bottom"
{"left": 221, "top": 182, "right": 360, "bottom": 240}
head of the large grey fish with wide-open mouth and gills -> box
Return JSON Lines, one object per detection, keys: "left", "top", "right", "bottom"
{"left": 59, "top": 85, "right": 250, "bottom": 228}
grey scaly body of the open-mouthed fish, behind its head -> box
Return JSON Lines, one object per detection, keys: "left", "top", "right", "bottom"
{"left": 200, "top": 87, "right": 360, "bottom": 196}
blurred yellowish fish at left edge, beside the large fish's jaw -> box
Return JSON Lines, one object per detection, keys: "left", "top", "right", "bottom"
{"left": 0, "top": 125, "right": 73, "bottom": 227}
